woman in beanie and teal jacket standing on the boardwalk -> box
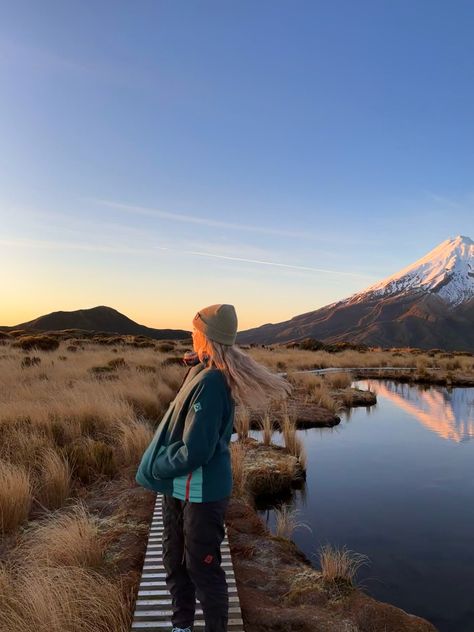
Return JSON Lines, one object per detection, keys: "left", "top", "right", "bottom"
{"left": 136, "top": 304, "right": 291, "bottom": 632}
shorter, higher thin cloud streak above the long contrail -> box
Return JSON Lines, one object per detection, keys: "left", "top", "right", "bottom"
{"left": 87, "top": 198, "right": 314, "bottom": 239}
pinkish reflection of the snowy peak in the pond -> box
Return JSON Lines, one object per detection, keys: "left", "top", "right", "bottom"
{"left": 359, "top": 380, "right": 474, "bottom": 443}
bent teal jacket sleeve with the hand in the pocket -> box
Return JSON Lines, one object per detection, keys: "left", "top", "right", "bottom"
{"left": 152, "top": 377, "right": 225, "bottom": 478}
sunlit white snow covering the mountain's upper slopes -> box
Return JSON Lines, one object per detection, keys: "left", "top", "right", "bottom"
{"left": 348, "top": 235, "right": 474, "bottom": 307}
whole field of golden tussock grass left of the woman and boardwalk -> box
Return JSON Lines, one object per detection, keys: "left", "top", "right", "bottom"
{"left": 0, "top": 338, "right": 191, "bottom": 632}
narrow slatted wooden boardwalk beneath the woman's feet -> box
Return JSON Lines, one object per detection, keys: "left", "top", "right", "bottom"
{"left": 132, "top": 492, "right": 244, "bottom": 632}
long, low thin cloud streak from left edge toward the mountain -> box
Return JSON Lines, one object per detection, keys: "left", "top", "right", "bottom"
{"left": 0, "top": 238, "right": 367, "bottom": 278}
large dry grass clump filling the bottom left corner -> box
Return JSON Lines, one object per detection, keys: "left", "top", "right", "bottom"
{"left": 0, "top": 566, "right": 131, "bottom": 632}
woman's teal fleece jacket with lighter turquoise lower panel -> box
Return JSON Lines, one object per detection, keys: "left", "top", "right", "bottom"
{"left": 135, "top": 362, "right": 235, "bottom": 503}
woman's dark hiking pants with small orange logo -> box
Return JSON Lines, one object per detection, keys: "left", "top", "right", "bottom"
{"left": 162, "top": 494, "right": 229, "bottom": 632}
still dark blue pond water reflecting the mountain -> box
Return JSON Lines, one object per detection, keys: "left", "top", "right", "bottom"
{"left": 250, "top": 380, "right": 474, "bottom": 632}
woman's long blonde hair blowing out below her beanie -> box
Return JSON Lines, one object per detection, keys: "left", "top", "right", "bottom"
{"left": 194, "top": 329, "right": 293, "bottom": 408}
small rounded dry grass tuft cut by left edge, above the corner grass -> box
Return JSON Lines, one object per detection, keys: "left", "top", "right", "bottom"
{"left": 0, "top": 461, "right": 32, "bottom": 535}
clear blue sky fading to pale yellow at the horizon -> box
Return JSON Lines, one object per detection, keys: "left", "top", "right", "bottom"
{"left": 0, "top": 0, "right": 474, "bottom": 330}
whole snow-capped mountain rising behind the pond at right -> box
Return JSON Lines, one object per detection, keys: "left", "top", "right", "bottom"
{"left": 236, "top": 235, "right": 474, "bottom": 351}
